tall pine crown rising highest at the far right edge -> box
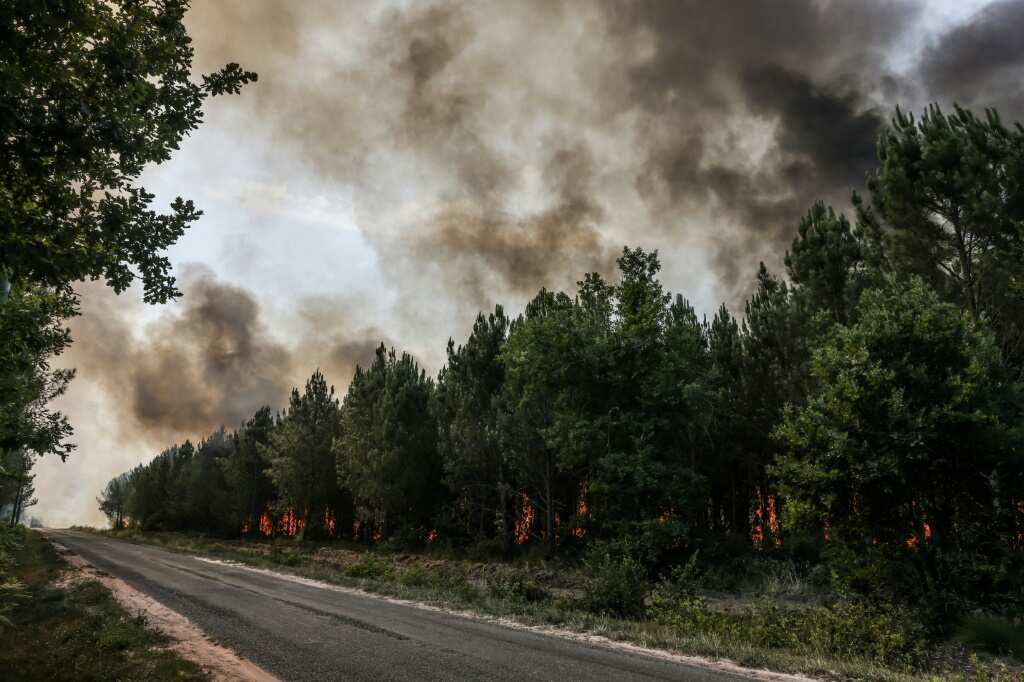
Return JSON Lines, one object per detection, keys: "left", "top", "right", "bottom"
{"left": 854, "top": 106, "right": 1024, "bottom": 367}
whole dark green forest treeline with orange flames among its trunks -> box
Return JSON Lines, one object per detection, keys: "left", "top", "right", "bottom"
{"left": 100, "top": 109, "right": 1024, "bottom": 610}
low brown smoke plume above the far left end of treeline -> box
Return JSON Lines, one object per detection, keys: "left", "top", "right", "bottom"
{"left": 66, "top": 267, "right": 383, "bottom": 446}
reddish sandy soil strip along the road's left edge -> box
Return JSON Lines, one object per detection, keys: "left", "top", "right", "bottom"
{"left": 52, "top": 543, "right": 278, "bottom": 682}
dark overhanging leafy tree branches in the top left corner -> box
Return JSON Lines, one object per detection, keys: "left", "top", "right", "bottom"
{"left": 0, "top": 0, "right": 256, "bottom": 302}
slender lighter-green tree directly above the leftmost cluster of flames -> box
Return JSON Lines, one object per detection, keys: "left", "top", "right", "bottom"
{"left": 262, "top": 370, "right": 340, "bottom": 539}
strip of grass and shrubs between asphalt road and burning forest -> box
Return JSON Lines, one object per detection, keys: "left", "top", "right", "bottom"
{"left": 79, "top": 528, "right": 1024, "bottom": 680}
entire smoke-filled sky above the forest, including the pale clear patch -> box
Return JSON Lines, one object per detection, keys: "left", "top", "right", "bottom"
{"left": 30, "top": 0, "right": 1024, "bottom": 526}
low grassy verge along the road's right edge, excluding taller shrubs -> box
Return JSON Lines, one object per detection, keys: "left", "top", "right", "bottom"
{"left": 70, "top": 530, "right": 1024, "bottom": 681}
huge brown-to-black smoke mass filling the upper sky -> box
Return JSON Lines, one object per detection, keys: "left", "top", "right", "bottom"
{"left": 176, "top": 0, "right": 920, "bottom": 303}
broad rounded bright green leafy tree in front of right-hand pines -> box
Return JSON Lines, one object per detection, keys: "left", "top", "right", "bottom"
{"left": 774, "top": 278, "right": 1021, "bottom": 583}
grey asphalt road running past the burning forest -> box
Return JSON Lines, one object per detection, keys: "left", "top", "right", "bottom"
{"left": 48, "top": 530, "right": 742, "bottom": 681}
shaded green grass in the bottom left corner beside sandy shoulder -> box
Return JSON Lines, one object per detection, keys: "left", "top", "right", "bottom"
{"left": 0, "top": 531, "right": 209, "bottom": 682}
